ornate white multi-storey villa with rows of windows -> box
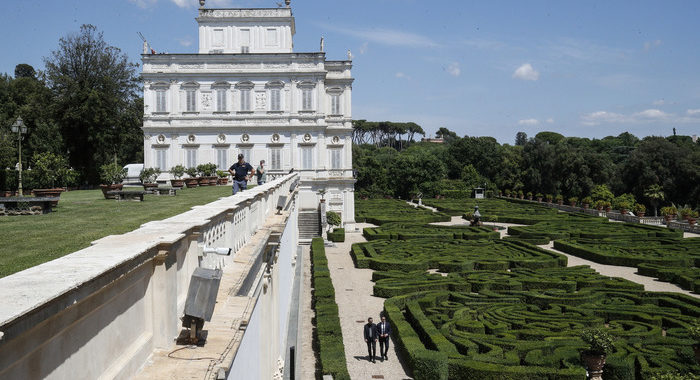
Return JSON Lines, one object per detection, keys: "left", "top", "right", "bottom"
{"left": 142, "top": 0, "right": 355, "bottom": 228}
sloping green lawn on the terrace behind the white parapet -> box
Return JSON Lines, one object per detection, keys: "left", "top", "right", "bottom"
{"left": 0, "top": 186, "right": 231, "bottom": 277}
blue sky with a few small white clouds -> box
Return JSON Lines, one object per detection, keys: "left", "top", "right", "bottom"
{"left": 0, "top": 0, "right": 700, "bottom": 143}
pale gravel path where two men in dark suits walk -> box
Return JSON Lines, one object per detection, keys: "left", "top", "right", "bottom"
{"left": 326, "top": 223, "right": 410, "bottom": 380}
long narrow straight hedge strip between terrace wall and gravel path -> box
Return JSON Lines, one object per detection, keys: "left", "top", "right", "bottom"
{"left": 311, "top": 238, "right": 350, "bottom": 380}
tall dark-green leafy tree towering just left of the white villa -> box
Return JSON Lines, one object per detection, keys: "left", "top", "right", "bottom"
{"left": 44, "top": 25, "right": 142, "bottom": 183}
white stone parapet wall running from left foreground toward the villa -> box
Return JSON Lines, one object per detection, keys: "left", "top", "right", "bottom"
{"left": 0, "top": 173, "right": 298, "bottom": 379}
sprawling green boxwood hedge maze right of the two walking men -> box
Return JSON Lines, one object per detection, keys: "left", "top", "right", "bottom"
{"left": 351, "top": 200, "right": 700, "bottom": 380}
